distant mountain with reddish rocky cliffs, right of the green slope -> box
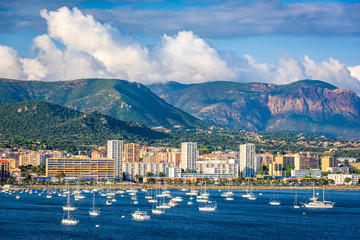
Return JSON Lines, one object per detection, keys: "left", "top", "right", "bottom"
{"left": 148, "top": 80, "right": 360, "bottom": 139}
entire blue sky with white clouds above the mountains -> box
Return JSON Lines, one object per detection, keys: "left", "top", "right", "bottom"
{"left": 0, "top": 0, "right": 360, "bottom": 95}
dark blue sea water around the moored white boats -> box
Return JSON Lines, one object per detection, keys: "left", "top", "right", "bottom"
{"left": 0, "top": 190, "right": 360, "bottom": 240}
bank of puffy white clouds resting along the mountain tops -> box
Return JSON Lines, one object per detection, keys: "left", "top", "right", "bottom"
{"left": 0, "top": 7, "right": 360, "bottom": 94}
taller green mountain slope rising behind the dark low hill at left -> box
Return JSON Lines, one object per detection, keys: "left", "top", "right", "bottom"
{"left": 0, "top": 79, "right": 207, "bottom": 128}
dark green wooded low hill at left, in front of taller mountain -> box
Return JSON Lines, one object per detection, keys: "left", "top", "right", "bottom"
{"left": 0, "top": 100, "right": 167, "bottom": 145}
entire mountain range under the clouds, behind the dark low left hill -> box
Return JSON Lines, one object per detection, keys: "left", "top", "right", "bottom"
{"left": 0, "top": 79, "right": 360, "bottom": 139}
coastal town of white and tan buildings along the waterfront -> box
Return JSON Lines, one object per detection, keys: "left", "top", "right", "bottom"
{"left": 0, "top": 140, "right": 360, "bottom": 186}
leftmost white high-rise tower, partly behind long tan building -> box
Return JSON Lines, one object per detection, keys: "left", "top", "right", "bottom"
{"left": 107, "top": 140, "right": 124, "bottom": 179}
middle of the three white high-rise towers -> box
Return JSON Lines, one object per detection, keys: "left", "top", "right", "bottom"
{"left": 181, "top": 142, "right": 199, "bottom": 171}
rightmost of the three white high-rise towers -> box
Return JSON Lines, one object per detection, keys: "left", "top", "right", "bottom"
{"left": 240, "top": 143, "right": 256, "bottom": 177}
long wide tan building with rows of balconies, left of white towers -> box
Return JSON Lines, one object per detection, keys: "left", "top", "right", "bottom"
{"left": 46, "top": 156, "right": 115, "bottom": 180}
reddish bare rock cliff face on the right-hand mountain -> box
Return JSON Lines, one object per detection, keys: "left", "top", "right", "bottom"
{"left": 267, "top": 86, "right": 360, "bottom": 121}
